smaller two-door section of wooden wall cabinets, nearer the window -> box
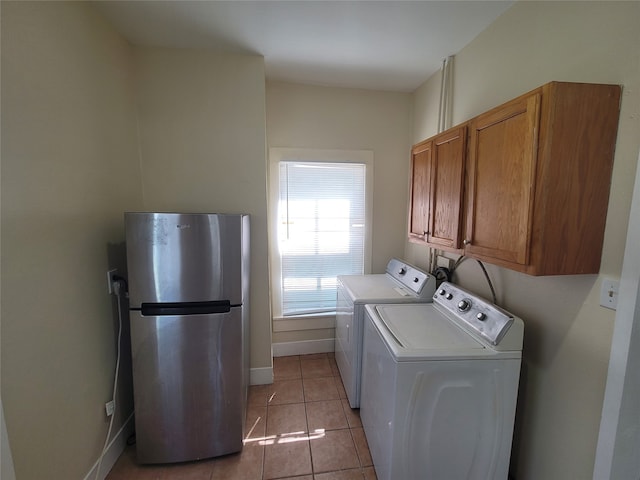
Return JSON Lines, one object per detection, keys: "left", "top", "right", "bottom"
{"left": 409, "top": 125, "right": 467, "bottom": 251}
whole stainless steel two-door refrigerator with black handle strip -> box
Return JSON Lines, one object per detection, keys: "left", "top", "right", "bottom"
{"left": 125, "top": 212, "right": 249, "bottom": 463}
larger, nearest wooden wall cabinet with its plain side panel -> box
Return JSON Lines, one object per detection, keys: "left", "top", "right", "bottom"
{"left": 412, "top": 82, "right": 621, "bottom": 275}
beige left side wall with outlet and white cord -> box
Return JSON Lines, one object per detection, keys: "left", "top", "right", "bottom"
{"left": 1, "top": 1, "right": 142, "bottom": 479}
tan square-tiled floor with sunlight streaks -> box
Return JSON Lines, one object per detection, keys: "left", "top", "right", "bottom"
{"left": 107, "top": 353, "right": 376, "bottom": 480}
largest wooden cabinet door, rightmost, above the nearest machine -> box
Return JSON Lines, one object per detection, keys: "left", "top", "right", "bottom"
{"left": 464, "top": 92, "right": 540, "bottom": 265}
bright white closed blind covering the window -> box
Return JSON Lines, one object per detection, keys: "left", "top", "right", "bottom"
{"left": 278, "top": 161, "right": 366, "bottom": 316}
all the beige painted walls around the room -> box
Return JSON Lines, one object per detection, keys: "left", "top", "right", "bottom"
{"left": 0, "top": 1, "right": 640, "bottom": 480}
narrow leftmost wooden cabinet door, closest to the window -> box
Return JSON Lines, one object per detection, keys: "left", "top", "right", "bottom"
{"left": 409, "top": 141, "right": 431, "bottom": 242}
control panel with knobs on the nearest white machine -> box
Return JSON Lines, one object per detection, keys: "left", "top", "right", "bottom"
{"left": 433, "top": 282, "right": 514, "bottom": 345}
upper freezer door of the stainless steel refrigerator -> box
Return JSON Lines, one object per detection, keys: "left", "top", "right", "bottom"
{"left": 125, "top": 213, "right": 249, "bottom": 308}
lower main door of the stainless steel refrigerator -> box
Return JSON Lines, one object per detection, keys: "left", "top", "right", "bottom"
{"left": 131, "top": 307, "right": 246, "bottom": 463}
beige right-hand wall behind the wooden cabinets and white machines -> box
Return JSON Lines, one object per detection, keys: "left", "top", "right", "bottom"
{"left": 406, "top": 1, "right": 640, "bottom": 480}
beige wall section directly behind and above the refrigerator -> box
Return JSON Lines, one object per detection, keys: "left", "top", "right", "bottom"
{"left": 135, "top": 48, "right": 271, "bottom": 378}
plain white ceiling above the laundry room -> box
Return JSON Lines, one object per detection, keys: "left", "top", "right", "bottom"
{"left": 92, "top": 0, "right": 513, "bottom": 92}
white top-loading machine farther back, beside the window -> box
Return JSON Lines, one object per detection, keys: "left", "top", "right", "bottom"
{"left": 335, "top": 258, "right": 436, "bottom": 408}
